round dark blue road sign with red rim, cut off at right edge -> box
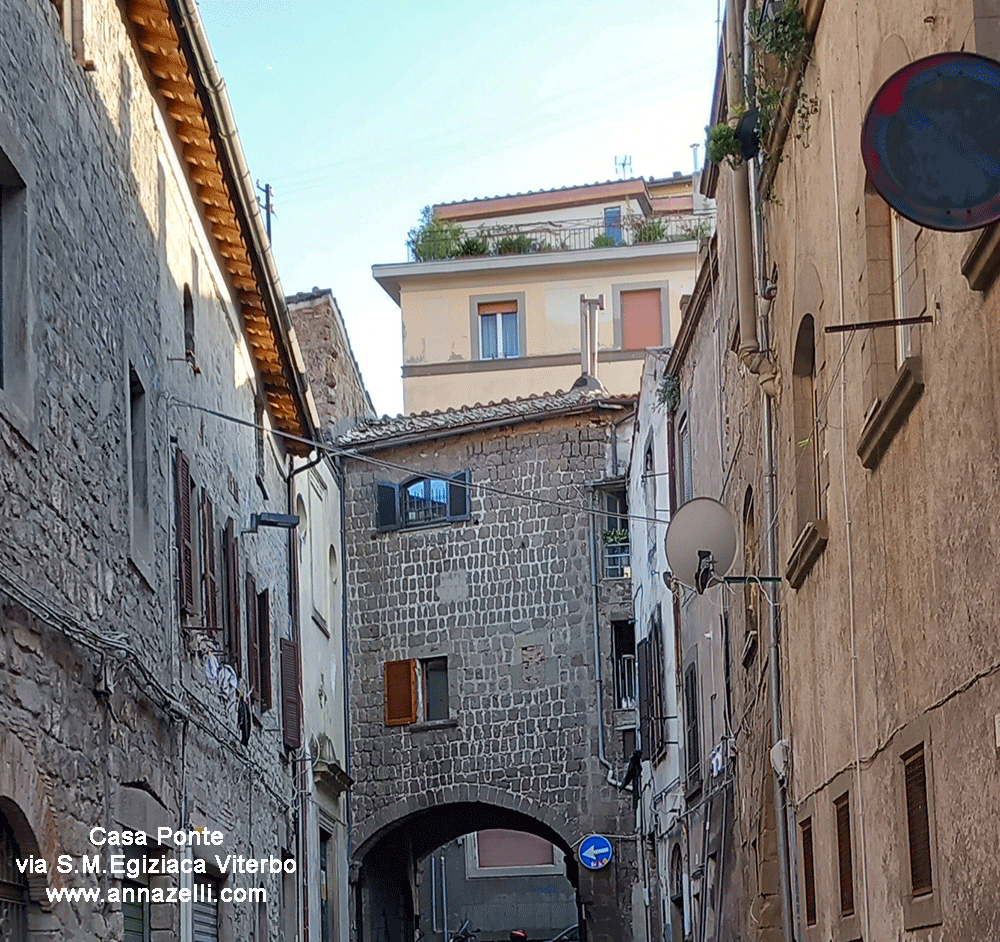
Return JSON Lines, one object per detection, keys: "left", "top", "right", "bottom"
{"left": 861, "top": 52, "right": 1000, "bottom": 232}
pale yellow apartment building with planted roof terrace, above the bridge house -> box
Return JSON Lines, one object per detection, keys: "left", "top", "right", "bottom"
{"left": 372, "top": 173, "right": 715, "bottom": 412}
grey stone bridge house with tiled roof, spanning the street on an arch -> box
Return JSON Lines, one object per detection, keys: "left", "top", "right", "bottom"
{"left": 337, "top": 392, "right": 637, "bottom": 942}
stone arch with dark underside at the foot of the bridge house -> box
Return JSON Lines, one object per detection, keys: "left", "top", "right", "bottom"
{"left": 352, "top": 789, "right": 580, "bottom": 942}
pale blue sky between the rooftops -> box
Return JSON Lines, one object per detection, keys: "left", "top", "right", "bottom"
{"left": 199, "top": 0, "right": 718, "bottom": 413}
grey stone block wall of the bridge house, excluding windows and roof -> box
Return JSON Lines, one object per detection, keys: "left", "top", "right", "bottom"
{"left": 343, "top": 409, "right": 635, "bottom": 942}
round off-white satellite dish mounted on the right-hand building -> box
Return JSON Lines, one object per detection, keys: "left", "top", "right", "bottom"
{"left": 665, "top": 497, "right": 736, "bottom": 593}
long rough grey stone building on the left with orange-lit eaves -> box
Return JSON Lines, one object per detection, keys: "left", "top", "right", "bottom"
{"left": 0, "top": 0, "right": 315, "bottom": 942}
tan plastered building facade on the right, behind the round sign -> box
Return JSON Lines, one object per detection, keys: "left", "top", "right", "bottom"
{"left": 671, "top": 0, "right": 1000, "bottom": 940}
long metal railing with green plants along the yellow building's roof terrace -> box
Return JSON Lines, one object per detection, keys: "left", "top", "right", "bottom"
{"left": 407, "top": 213, "right": 715, "bottom": 262}
